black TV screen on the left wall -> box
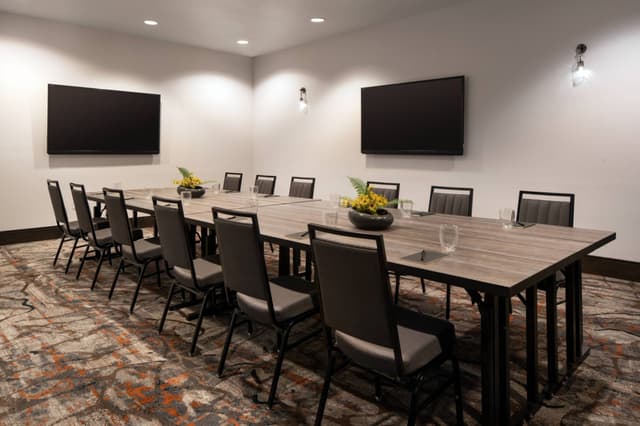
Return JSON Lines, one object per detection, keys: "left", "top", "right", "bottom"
{"left": 47, "top": 84, "right": 160, "bottom": 154}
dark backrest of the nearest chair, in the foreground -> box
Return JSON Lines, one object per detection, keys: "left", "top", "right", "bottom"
{"left": 309, "top": 224, "right": 402, "bottom": 372}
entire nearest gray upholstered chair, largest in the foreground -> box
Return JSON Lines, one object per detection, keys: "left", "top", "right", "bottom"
{"left": 309, "top": 224, "right": 463, "bottom": 425}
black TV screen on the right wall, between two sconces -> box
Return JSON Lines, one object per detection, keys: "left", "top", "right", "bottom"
{"left": 361, "top": 76, "right": 465, "bottom": 155}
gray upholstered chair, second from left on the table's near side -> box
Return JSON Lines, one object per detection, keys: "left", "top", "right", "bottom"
{"left": 70, "top": 183, "right": 113, "bottom": 290}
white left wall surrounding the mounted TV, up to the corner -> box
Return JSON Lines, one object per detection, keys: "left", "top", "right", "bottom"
{"left": 0, "top": 14, "right": 252, "bottom": 231}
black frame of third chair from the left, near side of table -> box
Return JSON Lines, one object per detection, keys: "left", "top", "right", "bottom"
{"left": 102, "top": 188, "right": 162, "bottom": 313}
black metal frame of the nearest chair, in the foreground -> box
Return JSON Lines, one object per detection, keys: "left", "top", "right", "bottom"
{"left": 308, "top": 224, "right": 463, "bottom": 426}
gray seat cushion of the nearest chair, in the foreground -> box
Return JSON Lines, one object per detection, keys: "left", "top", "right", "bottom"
{"left": 335, "top": 307, "right": 455, "bottom": 376}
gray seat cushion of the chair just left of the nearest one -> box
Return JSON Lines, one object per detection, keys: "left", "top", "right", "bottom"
{"left": 237, "top": 276, "right": 317, "bottom": 323}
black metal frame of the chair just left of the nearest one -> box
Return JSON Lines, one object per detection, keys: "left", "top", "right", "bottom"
{"left": 212, "top": 207, "right": 322, "bottom": 408}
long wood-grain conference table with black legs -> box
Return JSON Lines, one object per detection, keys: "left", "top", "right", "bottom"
{"left": 89, "top": 189, "right": 616, "bottom": 425}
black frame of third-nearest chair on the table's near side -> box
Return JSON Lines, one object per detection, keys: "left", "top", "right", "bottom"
{"left": 152, "top": 196, "right": 226, "bottom": 356}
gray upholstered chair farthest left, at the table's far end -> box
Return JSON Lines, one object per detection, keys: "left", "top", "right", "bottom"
{"left": 47, "top": 179, "right": 109, "bottom": 274}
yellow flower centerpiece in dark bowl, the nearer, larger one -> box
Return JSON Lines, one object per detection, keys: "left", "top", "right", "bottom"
{"left": 346, "top": 177, "right": 393, "bottom": 231}
